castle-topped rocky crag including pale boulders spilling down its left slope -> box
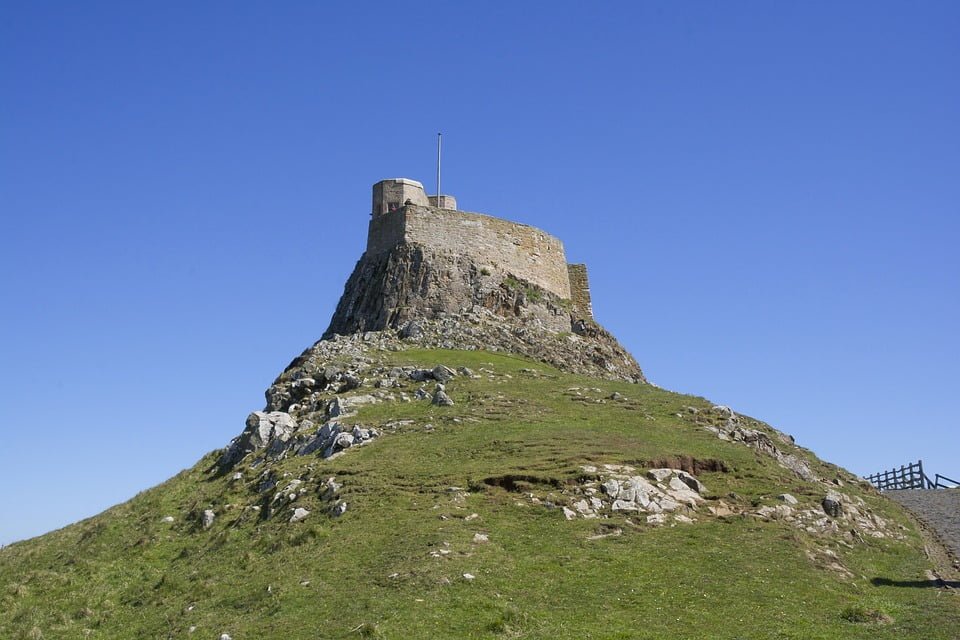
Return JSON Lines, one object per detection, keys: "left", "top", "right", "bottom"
{"left": 219, "top": 179, "right": 646, "bottom": 472}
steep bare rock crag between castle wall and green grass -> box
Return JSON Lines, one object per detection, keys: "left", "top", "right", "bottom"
{"left": 323, "top": 244, "right": 646, "bottom": 382}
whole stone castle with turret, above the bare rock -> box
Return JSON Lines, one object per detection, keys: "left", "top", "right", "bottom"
{"left": 365, "top": 178, "right": 593, "bottom": 319}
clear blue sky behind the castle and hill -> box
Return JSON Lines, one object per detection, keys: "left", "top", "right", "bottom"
{"left": 0, "top": 1, "right": 960, "bottom": 542}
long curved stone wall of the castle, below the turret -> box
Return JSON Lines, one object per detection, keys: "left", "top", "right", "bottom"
{"left": 367, "top": 206, "right": 570, "bottom": 299}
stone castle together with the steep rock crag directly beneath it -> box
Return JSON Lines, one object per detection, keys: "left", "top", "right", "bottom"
{"left": 323, "top": 179, "right": 645, "bottom": 382}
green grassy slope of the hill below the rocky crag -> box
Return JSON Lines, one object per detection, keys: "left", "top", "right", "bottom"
{"left": 0, "top": 350, "right": 960, "bottom": 640}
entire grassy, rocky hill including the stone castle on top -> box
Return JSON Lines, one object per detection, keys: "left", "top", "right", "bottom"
{"left": 0, "top": 192, "right": 960, "bottom": 640}
